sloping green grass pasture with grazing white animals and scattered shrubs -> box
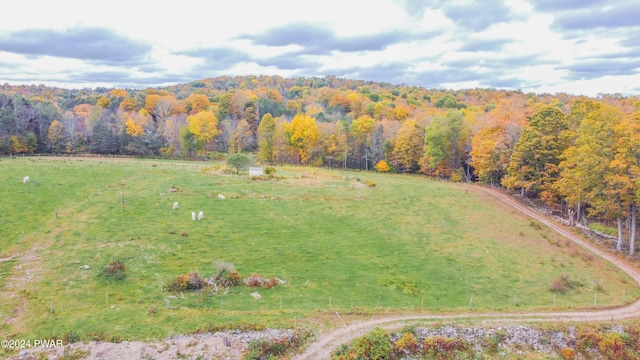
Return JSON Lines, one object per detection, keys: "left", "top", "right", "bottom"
{"left": 0, "top": 158, "right": 640, "bottom": 340}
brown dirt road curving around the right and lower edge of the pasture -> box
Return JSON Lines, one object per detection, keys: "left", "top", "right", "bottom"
{"left": 293, "top": 186, "right": 640, "bottom": 360}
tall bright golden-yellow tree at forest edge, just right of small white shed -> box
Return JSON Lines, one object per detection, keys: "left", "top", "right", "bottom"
{"left": 282, "top": 113, "right": 319, "bottom": 164}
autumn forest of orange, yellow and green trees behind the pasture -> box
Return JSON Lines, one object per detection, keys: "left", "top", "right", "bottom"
{"left": 0, "top": 76, "right": 640, "bottom": 255}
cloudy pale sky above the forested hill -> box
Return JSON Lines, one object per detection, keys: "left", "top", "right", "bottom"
{"left": 0, "top": 0, "right": 640, "bottom": 96}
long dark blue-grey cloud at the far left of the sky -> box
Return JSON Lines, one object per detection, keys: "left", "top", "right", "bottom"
{"left": 0, "top": 28, "right": 151, "bottom": 64}
